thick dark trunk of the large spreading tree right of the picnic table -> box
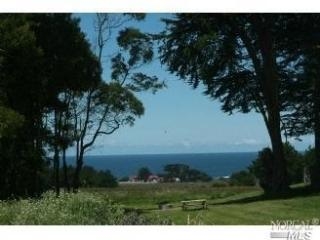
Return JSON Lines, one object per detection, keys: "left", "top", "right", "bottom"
{"left": 256, "top": 16, "right": 288, "bottom": 194}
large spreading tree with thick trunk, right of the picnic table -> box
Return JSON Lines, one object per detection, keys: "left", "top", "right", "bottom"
{"left": 160, "top": 14, "right": 310, "bottom": 193}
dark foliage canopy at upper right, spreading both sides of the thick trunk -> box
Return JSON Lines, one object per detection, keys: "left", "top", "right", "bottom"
{"left": 159, "top": 13, "right": 312, "bottom": 117}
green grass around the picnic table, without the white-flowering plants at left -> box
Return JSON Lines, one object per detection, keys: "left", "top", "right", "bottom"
{"left": 89, "top": 183, "right": 320, "bottom": 225}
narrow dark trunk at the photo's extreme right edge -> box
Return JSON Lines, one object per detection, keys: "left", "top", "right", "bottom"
{"left": 310, "top": 79, "right": 320, "bottom": 191}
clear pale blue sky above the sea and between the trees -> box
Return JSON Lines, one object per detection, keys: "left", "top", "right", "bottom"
{"left": 72, "top": 14, "right": 313, "bottom": 155}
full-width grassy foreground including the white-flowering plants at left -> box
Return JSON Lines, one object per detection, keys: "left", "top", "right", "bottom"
{"left": 0, "top": 183, "right": 320, "bottom": 225}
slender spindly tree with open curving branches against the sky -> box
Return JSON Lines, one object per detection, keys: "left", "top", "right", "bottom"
{"left": 73, "top": 14, "right": 164, "bottom": 191}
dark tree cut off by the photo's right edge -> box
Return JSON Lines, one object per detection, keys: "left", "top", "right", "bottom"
{"left": 282, "top": 14, "right": 320, "bottom": 190}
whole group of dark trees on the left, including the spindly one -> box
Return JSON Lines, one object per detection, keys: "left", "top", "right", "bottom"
{"left": 0, "top": 14, "right": 164, "bottom": 199}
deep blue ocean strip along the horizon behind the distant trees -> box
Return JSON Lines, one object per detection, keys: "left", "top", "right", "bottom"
{"left": 67, "top": 152, "right": 257, "bottom": 178}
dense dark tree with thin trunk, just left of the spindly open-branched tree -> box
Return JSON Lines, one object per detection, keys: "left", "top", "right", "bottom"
{"left": 31, "top": 14, "right": 101, "bottom": 194}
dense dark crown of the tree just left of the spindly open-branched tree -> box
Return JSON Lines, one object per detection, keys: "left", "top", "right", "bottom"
{"left": 30, "top": 14, "right": 101, "bottom": 95}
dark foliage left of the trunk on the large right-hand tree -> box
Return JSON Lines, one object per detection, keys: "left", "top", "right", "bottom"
{"left": 160, "top": 14, "right": 261, "bottom": 114}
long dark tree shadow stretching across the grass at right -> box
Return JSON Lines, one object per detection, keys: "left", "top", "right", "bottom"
{"left": 208, "top": 186, "right": 320, "bottom": 206}
